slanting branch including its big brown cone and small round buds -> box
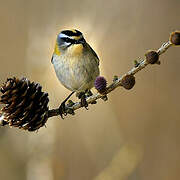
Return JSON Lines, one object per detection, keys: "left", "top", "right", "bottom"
{"left": 0, "top": 31, "right": 180, "bottom": 131}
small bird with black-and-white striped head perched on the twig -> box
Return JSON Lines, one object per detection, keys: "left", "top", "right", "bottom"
{"left": 51, "top": 29, "right": 100, "bottom": 118}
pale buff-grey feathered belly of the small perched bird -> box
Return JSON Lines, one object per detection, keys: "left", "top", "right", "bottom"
{"left": 53, "top": 58, "right": 99, "bottom": 92}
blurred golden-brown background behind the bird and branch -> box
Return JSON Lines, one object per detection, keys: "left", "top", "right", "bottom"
{"left": 0, "top": 0, "right": 180, "bottom": 180}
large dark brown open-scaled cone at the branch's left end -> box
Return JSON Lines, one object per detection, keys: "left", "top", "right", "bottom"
{"left": 0, "top": 77, "right": 49, "bottom": 131}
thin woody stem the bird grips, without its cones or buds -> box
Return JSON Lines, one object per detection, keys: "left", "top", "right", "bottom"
{"left": 48, "top": 41, "right": 173, "bottom": 117}
